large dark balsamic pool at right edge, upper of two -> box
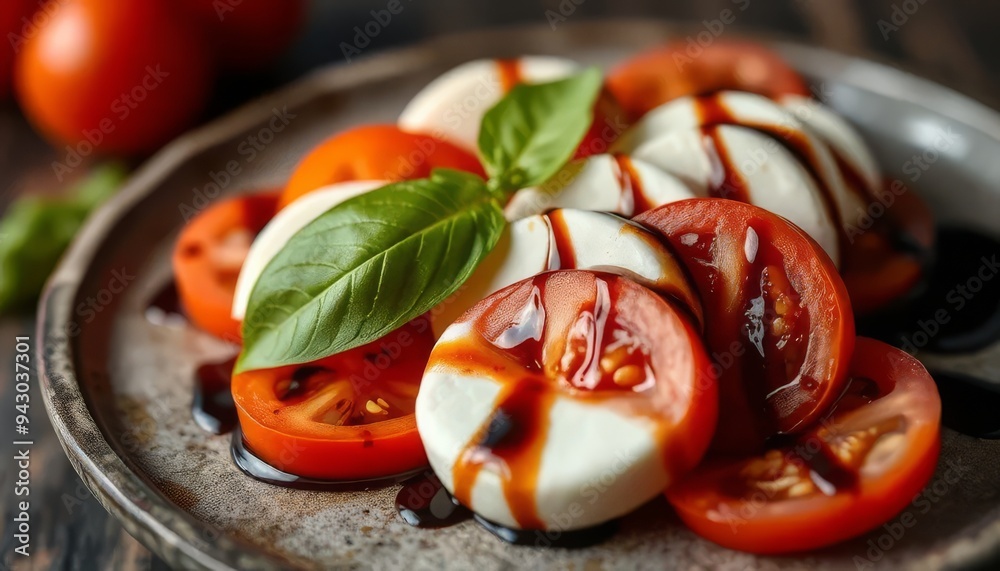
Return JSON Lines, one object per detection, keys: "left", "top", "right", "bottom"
{"left": 857, "top": 228, "right": 1000, "bottom": 353}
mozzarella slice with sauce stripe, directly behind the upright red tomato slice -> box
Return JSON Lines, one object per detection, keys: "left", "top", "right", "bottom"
{"left": 634, "top": 125, "right": 839, "bottom": 261}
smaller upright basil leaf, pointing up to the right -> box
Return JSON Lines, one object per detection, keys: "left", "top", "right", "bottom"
{"left": 479, "top": 68, "right": 601, "bottom": 191}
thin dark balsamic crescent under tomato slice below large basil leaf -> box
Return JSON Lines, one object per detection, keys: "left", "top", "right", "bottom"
{"left": 230, "top": 426, "right": 423, "bottom": 492}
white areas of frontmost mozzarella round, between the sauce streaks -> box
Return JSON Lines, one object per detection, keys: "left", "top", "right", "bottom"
{"left": 415, "top": 336, "right": 670, "bottom": 531}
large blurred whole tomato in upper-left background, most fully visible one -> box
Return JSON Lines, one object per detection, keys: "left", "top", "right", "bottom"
{"left": 15, "top": 0, "right": 211, "bottom": 155}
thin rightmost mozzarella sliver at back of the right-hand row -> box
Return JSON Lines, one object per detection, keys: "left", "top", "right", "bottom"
{"left": 781, "top": 95, "right": 882, "bottom": 189}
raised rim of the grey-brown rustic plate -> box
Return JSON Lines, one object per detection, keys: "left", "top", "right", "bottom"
{"left": 36, "top": 18, "right": 1000, "bottom": 569}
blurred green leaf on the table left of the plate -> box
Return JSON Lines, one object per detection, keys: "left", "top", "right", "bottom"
{"left": 0, "top": 163, "right": 127, "bottom": 314}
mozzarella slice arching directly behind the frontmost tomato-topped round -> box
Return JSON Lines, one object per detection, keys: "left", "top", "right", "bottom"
{"left": 431, "top": 208, "right": 701, "bottom": 335}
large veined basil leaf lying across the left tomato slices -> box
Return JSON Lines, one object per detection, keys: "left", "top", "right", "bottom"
{"left": 236, "top": 170, "right": 506, "bottom": 372}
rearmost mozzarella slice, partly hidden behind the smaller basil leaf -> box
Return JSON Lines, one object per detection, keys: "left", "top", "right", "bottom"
{"left": 398, "top": 56, "right": 580, "bottom": 154}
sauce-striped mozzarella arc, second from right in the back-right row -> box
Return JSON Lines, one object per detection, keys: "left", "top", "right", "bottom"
{"left": 614, "top": 91, "right": 864, "bottom": 241}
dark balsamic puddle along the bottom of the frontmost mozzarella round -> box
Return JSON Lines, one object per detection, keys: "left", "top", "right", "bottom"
{"left": 396, "top": 470, "right": 618, "bottom": 549}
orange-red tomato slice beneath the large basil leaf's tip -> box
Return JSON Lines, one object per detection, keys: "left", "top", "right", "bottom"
{"left": 232, "top": 316, "right": 434, "bottom": 480}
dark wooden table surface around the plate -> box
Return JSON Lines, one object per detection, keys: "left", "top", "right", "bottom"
{"left": 0, "top": 0, "right": 1000, "bottom": 570}
